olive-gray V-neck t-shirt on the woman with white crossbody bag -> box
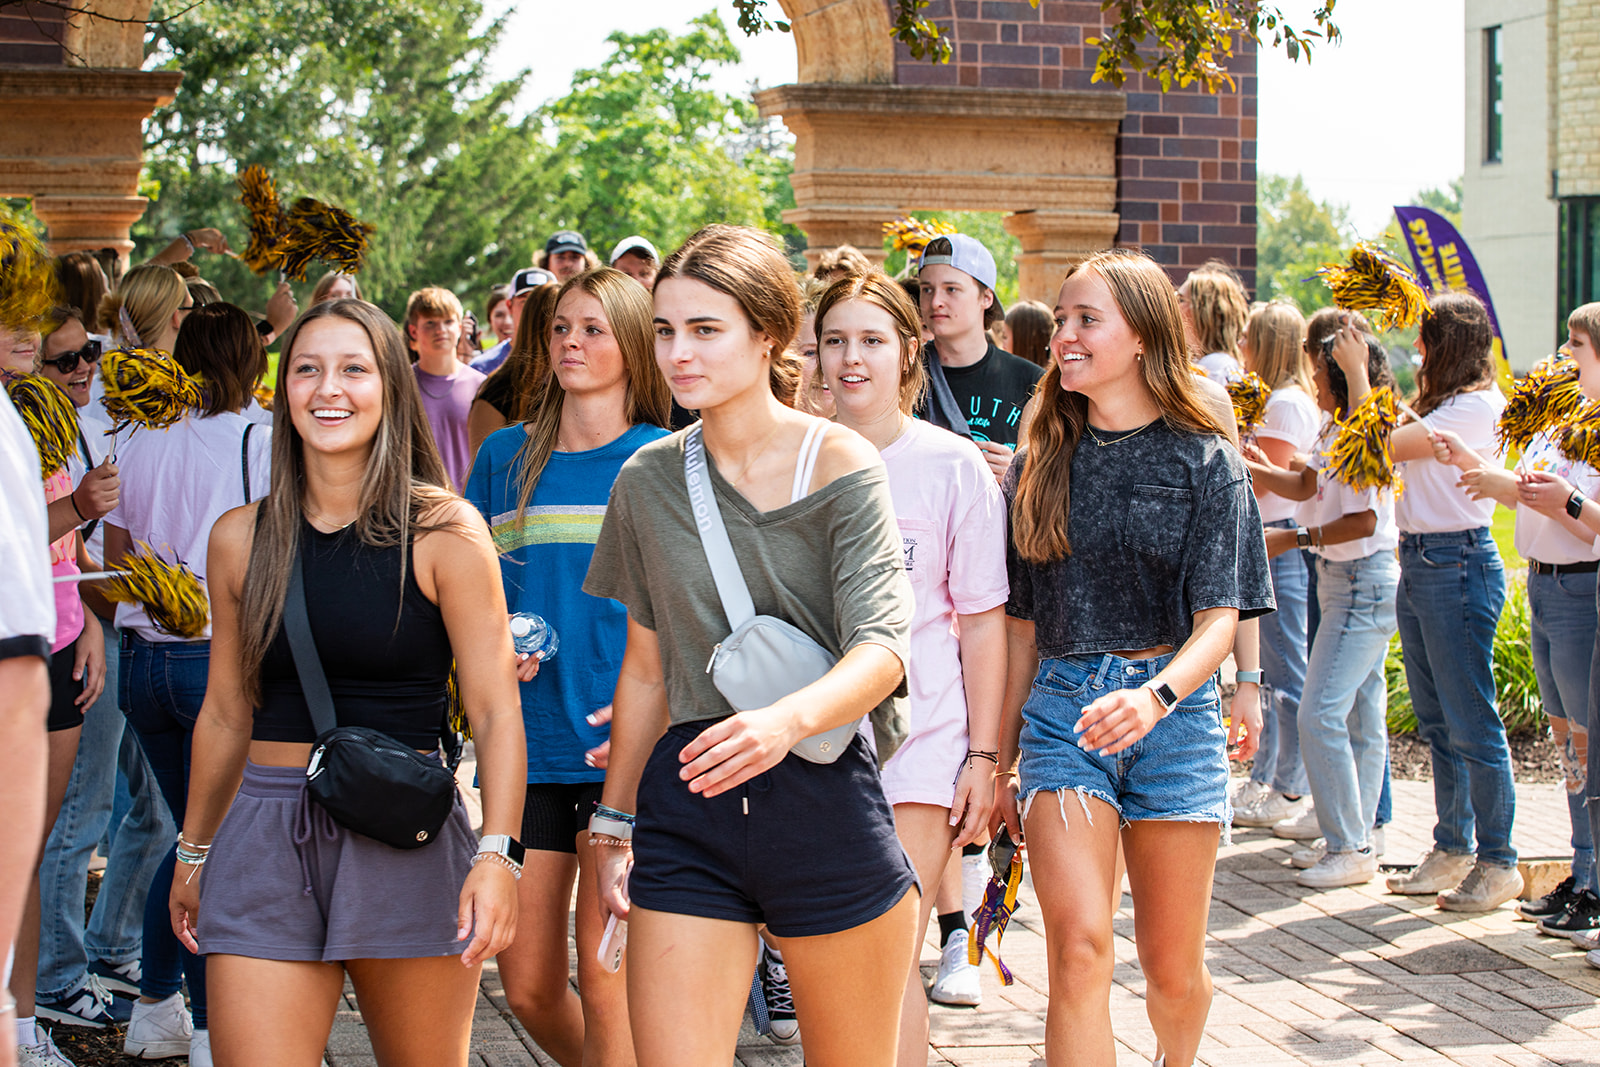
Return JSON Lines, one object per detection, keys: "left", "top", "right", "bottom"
{"left": 584, "top": 430, "right": 912, "bottom": 761}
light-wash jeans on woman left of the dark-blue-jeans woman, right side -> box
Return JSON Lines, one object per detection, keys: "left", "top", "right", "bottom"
{"left": 1299, "top": 552, "right": 1400, "bottom": 853}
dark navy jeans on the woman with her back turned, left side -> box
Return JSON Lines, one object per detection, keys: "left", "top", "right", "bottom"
{"left": 118, "top": 630, "right": 211, "bottom": 1030}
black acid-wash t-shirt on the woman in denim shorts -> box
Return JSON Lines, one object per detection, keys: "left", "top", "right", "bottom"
{"left": 1000, "top": 421, "right": 1274, "bottom": 659}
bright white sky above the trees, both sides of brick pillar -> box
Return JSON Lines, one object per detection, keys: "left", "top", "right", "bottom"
{"left": 494, "top": 0, "right": 1466, "bottom": 237}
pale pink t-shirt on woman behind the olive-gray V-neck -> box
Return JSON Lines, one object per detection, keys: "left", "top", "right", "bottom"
{"left": 883, "top": 419, "right": 1011, "bottom": 808}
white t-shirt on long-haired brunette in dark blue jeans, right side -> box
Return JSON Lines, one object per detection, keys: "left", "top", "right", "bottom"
{"left": 1395, "top": 386, "right": 1506, "bottom": 533}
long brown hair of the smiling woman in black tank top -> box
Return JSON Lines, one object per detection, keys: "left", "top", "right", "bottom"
{"left": 238, "top": 299, "right": 458, "bottom": 697}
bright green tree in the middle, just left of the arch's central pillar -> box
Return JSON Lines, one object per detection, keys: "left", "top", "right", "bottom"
{"left": 544, "top": 11, "right": 803, "bottom": 262}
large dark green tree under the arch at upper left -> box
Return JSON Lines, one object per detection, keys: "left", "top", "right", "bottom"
{"left": 134, "top": 0, "right": 555, "bottom": 314}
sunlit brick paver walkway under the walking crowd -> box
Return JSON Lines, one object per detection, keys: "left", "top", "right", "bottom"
{"left": 318, "top": 782, "right": 1600, "bottom": 1067}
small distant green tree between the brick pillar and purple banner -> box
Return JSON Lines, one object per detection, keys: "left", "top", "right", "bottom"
{"left": 1256, "top": 174, "right": 1354, "bottom": 315}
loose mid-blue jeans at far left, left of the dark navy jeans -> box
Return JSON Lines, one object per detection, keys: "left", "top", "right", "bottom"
{"left": 37, "top": 616, "right": 176, "bottom": 998}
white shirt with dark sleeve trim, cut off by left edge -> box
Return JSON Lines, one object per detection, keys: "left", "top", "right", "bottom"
{"left": 0, "top": 389, "right": 56, "bottom": 659}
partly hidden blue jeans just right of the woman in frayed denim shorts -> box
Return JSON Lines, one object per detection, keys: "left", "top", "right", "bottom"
{"left": 1250, "top": 518, "right": 1309, "bottom": 797}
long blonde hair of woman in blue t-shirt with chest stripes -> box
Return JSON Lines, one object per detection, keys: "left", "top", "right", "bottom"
{"left": 517, "top": 267, "right": 672, "bottom": 520}
